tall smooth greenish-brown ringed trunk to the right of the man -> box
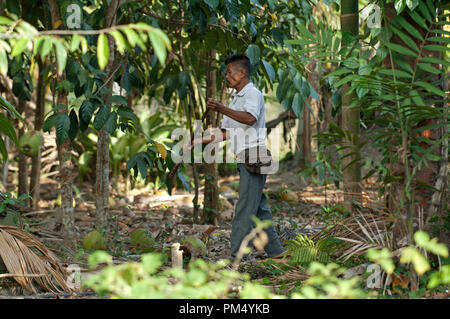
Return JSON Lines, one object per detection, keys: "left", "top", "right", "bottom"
{"left": 341, "top": 0, "right": 361, "bottom": 212}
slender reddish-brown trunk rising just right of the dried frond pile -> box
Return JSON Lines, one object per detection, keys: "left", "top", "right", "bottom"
{"left": 48, "top": 0, "right": 77, "bottom": 249}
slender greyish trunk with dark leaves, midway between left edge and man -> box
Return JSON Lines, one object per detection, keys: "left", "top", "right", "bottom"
{"left": 95, "top": 0, "right": 120, "bottom": 230}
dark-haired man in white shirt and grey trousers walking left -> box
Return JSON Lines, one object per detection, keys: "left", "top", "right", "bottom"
{"left": 186, "top": 55, "right": 283, "bottom": 260}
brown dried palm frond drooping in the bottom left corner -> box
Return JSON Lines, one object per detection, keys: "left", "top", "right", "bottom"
{"left": 0, "top": 225, "right": 72, "bottom": 294}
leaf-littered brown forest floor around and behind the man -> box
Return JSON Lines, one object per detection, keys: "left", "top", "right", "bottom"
{"left": 0, "top": 162, "right": 449, "bottom": 298}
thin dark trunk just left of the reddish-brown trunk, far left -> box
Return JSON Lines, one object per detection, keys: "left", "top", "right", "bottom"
{"left": 30, "top": 58, "right": 46, "bottom": 209}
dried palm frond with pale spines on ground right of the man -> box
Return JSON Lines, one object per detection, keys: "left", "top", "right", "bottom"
{"left": 311, "top": 205, "right": 394, "bottom": 261}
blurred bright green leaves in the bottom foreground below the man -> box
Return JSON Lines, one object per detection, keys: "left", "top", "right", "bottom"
{"left": 82, "top": 252, "right": 278, "bottom": 299}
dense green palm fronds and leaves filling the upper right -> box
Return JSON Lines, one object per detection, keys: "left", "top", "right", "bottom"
{"left": 286, "top": 1, "right": 449, "bottom": 245}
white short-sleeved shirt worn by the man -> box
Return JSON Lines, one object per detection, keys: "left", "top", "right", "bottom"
{"left": 221, "top": 82, "right": 266, "bottom": 155}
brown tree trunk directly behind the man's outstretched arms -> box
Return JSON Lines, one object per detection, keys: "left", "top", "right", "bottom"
{"left": 202, "top": 49, "right": 219, "bottom": 226}
